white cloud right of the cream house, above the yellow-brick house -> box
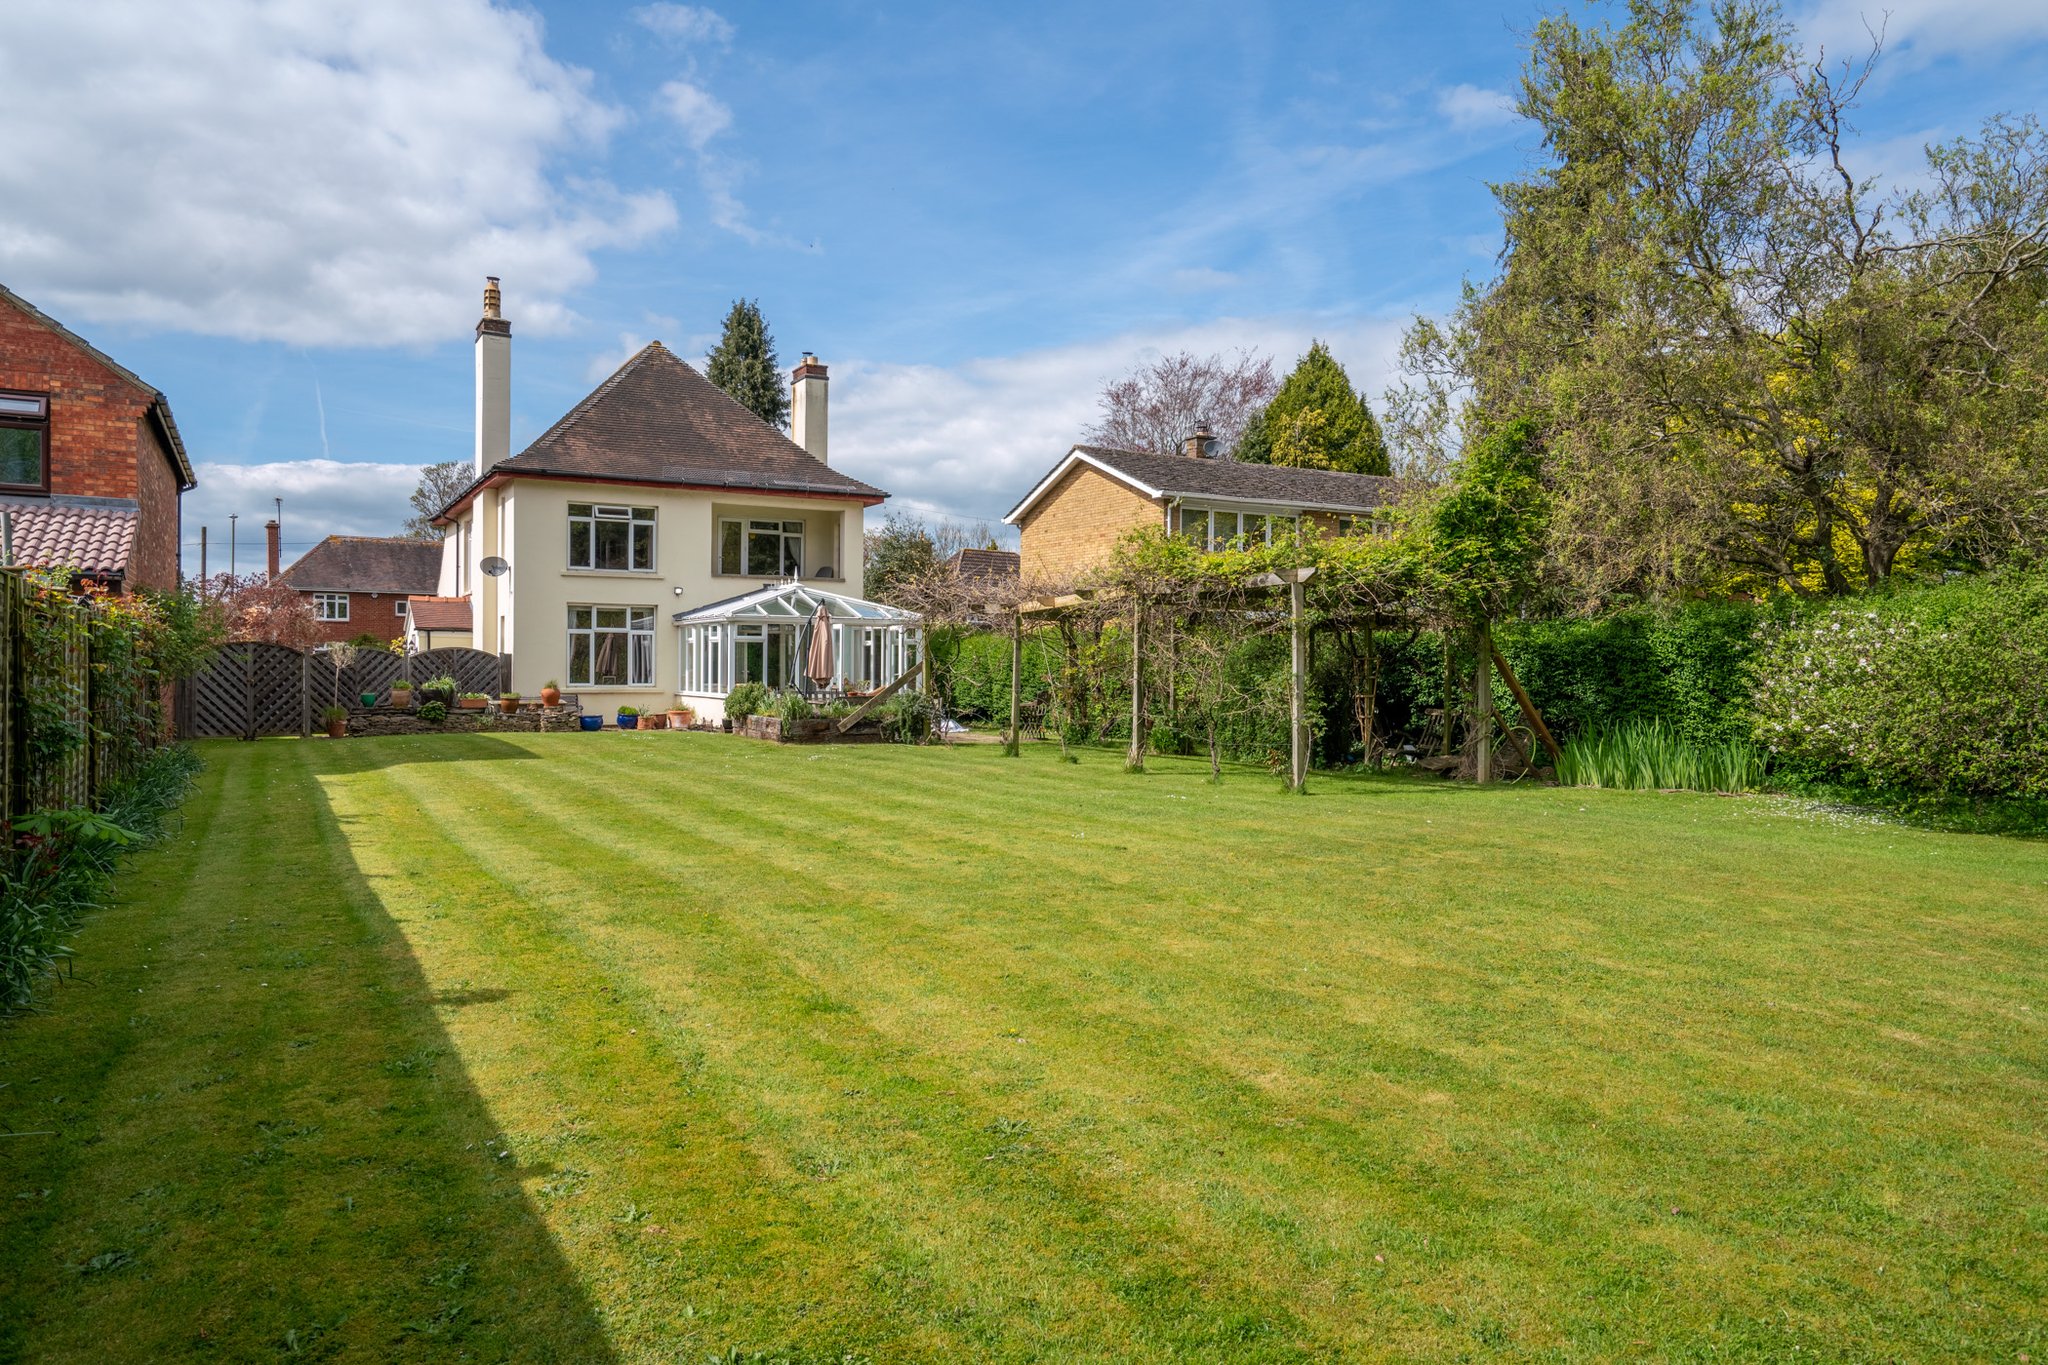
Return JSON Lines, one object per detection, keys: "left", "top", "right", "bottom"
{"left": 827, "top": 317, "right": 1405, "bottom": 522}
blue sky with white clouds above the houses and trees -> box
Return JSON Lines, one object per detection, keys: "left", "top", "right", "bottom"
{"left": 0, "top": 0, "right": 2048, "bottom": 567}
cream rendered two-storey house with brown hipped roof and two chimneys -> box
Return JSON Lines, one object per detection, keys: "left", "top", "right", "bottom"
{"left": 436, "top": 278, "right": 920, "bottom": 718}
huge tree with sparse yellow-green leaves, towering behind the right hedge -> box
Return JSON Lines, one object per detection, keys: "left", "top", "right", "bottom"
{"left": 1405, "top": 0, "right": 2048, "bottom": 600}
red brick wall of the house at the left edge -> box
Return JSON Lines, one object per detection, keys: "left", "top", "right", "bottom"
{"left": 0, "top": 290, "right": 180, "bottom": 587}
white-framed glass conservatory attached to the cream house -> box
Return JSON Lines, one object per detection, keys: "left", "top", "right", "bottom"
{"left": 674, "top": 581, "right": 924, "bottom": 720}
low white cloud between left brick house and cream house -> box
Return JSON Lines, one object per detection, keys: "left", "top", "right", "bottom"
{"left": 182, "top": 460, "right": 420, "bottom": 573}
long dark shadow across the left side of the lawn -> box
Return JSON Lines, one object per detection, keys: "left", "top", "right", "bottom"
{"left": 0, "top": 741, "right": 616, "bottom": 1365}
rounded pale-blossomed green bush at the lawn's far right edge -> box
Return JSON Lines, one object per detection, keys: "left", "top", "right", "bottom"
{"left": 1755, "top": 569, "right": 2048, "bottom": 798}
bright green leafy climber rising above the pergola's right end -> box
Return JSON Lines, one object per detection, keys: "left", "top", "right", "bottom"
{"left": 1427, "top": 420, "right": 1550, "bottom": 624}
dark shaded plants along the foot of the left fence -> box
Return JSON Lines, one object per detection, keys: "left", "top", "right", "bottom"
{"left": 0, "top": 745, "right": 199, "bottom": 1013}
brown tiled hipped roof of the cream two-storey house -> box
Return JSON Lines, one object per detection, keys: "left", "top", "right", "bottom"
{"left": 493, "top": 342, "right": 887, "bottom": 499}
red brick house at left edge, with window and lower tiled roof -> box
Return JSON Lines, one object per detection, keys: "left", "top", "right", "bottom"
{"left": 0, "top": 284, "right": 197, "bottom": 589}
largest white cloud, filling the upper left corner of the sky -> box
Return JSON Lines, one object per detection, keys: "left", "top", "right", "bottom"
{"left": 0, "top": 0, "right": 676, "bottom": 346}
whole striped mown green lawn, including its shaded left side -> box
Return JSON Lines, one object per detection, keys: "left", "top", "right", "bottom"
{"left": 0, "top": 735, "right": 2048, "bottom": 1361}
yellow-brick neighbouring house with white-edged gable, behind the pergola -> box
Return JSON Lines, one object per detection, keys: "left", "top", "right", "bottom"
{"left": 1004, "top": 426, "right": 1401, "bottom": 583}
